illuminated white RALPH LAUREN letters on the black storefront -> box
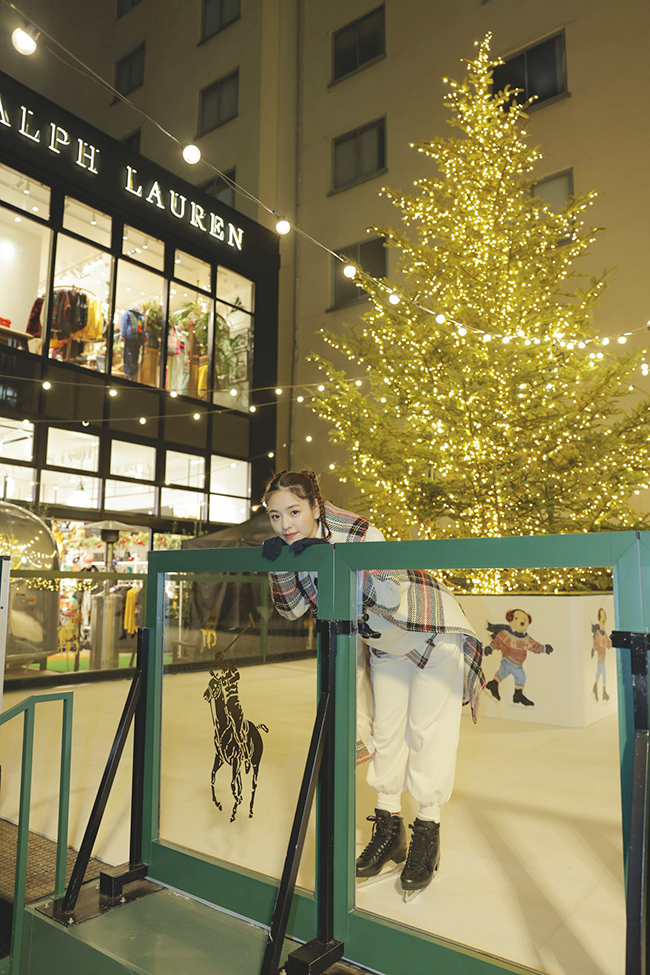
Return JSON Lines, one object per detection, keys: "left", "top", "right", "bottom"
{"left": 0, "top": 94, "right": 244, "bottom": 251}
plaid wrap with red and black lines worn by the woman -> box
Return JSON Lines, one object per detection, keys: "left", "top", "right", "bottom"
{"left": 269, "top": 501, "right": 485, "bottom": 721}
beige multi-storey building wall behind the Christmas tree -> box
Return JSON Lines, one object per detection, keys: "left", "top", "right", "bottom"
{"left": 0, "top": 0, "right": 650, "bottom": 504}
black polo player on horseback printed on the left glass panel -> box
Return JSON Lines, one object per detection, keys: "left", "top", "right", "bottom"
{"left": 203, "top": 664, "right": 269, "bottom": 823}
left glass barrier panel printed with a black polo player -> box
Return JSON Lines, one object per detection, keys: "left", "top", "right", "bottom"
{"left": 160, "top": 572, "right": 317, "bottom": 890}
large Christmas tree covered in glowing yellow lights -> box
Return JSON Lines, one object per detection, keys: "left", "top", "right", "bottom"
{"left": 311, "top": 37, "right": 650, "bottom": 572}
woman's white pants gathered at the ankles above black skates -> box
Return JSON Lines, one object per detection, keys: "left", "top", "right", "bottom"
{"left": 368, "top": 633, "right": 464, "bottom": 822}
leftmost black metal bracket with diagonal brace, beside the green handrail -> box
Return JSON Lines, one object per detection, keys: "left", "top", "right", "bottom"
{"left": 39, "top": 628, "right": 151, "bottom": 925}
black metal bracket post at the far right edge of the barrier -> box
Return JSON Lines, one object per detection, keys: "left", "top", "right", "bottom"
{"left": 611, "top": 630, "right": 650, "bottom": 975}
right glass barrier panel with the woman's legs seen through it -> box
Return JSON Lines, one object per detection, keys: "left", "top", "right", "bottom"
{"left": 355, "top": 569, "right": 625, "bottom": 975}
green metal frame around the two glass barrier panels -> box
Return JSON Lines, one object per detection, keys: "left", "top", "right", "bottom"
{"left": 143, "top": 532, "right": 650, "bottom": 975}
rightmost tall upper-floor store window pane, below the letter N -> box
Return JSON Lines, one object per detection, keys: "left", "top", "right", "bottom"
{"left": 212, "top": 301, "right": 253, "bottom": 409}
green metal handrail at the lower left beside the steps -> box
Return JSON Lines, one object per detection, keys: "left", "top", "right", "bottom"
{"left": 0, "top": 691, "right": 72, "bottom": 975}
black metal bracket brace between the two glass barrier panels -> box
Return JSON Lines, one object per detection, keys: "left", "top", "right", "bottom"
{"left": 261, "top": 619, "right": 344, "bottom": 975}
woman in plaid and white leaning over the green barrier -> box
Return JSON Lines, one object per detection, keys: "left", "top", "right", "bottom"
{"left": 263, "top": 470, "right": 485, "bottom": 891}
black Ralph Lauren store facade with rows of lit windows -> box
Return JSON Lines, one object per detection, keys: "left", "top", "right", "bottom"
{"left": 0, "top": 74, "right": 279, "bottom": 533}
